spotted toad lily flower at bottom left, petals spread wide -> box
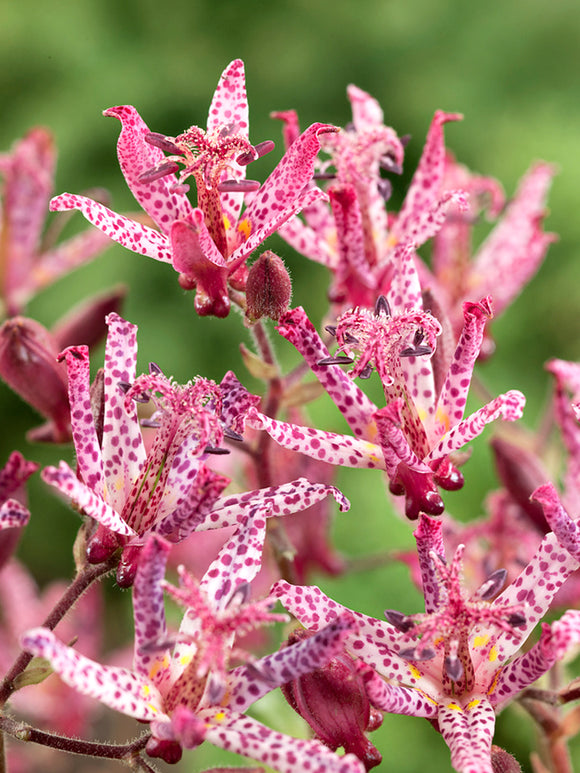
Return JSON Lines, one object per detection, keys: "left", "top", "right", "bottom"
{"left": 23, "top": 507, "right": 364, "bottom": 773}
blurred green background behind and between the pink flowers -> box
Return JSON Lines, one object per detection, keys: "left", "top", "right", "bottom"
{"left": 0, "top": 0, "right": 580, "bottom": 773}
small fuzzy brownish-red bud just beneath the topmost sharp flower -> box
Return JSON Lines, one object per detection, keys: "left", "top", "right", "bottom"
{"left": 246, "top": 250, "right": 292, "bottom": 322}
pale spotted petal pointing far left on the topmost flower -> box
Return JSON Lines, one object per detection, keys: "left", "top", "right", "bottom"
{"left": 50, "top": 193, "right": 172, "bottom": 263}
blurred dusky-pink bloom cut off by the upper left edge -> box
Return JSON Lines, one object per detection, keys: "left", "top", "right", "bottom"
{"left": 0, "top": 127, "right": 110, "bottom": 317}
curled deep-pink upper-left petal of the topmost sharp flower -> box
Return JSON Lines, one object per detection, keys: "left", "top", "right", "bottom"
{"left": 103, "top": 105, "right": 192, "bottom": 232}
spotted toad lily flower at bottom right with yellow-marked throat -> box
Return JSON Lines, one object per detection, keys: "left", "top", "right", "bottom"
{"left": 273, "top": 494, "right": 580, "bottom": 773}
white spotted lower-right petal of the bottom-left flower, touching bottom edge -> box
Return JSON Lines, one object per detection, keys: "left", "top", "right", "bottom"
{"left": 200, "top": 709, "right": 365, "bottom": 773}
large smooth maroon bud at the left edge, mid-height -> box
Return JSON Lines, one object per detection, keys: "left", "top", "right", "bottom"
{"left": 0, "top": 317, "right": 70, "bottom": 443}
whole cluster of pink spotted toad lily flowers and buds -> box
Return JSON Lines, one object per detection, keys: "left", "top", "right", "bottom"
{"left": 0, "top": 54, "right": 580, "bottom": 773}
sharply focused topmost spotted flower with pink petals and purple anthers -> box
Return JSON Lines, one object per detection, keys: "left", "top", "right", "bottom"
{"left": 51, "top": 60, "right": 337, "bottom": 317}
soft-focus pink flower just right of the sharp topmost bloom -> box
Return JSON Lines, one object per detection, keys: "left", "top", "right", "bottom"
{"left": 274, "top": 85, "right": 466, "bottom": 308}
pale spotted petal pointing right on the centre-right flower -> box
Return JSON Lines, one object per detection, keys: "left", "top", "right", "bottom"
{"left": 425, "top": 389, "right": 526, "bottom": 467}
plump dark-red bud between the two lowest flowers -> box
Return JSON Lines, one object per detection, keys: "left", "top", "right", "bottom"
{"left": 281, "top": 631, "right": 382, "bottom": 770}
